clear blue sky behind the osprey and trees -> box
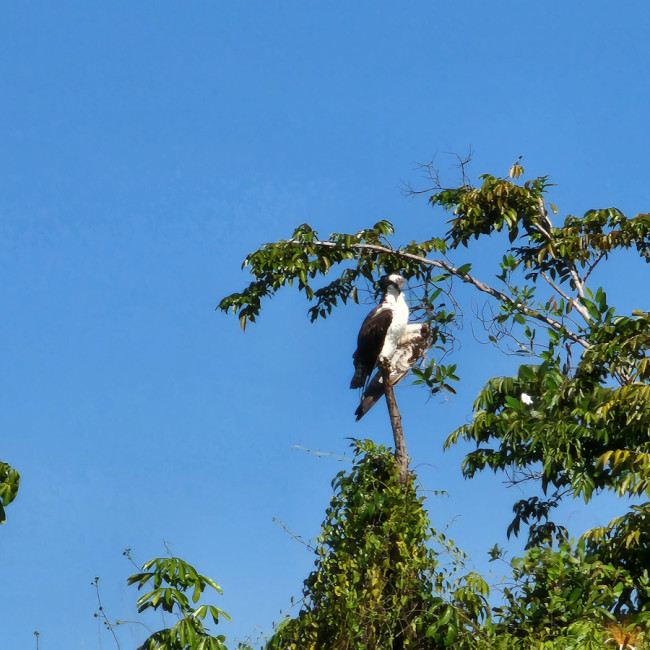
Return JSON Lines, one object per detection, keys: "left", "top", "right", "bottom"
{"left": 0, "top": 0, "right": 650, "bottom": 650}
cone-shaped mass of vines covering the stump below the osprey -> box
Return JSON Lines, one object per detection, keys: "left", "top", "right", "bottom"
{"left": 267, "top": 440, "right": 489, "bottom": 650}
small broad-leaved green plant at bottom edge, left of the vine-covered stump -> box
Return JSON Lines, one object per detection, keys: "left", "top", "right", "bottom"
{"left": 127, "top": 557, "right": 251, "bottom": 650}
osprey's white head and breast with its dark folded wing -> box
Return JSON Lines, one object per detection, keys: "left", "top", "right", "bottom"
{"left": 350, "top": 274, "right": 409, "bottom": 388}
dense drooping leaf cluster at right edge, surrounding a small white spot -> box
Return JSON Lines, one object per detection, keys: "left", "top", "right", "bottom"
{"left": 446, "top": 312, "right": 650, "bottom": 543}
